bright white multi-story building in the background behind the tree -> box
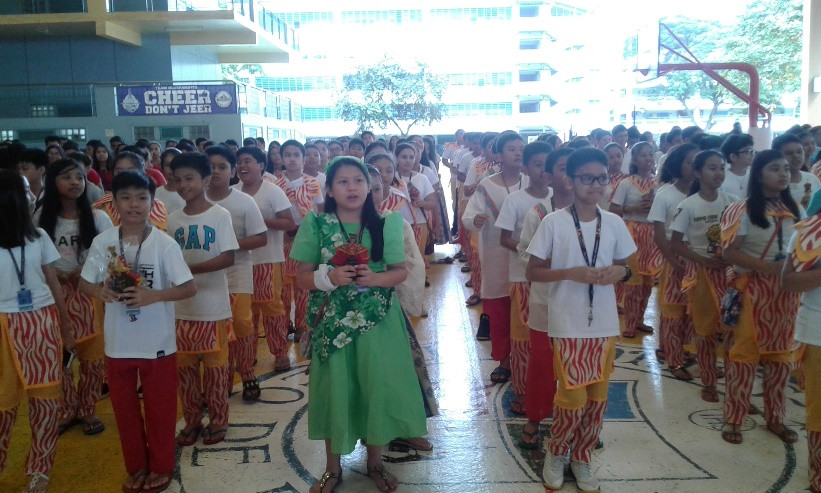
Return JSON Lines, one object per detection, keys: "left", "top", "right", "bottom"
{"left": 256, "top": 0, "right": 635, "bottom": 136}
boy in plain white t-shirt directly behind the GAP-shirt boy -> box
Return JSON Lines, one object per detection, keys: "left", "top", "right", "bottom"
{"left": 205, "top": 145, "right": 268, "bottom": 401}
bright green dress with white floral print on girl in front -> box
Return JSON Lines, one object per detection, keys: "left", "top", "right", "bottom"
{"left": 291, "top": 212, "right": 427, "bottom": 454}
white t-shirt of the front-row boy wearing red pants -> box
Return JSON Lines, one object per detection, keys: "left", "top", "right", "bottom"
{"left": 80, "top": 227, "right": 193, "bottom": 359}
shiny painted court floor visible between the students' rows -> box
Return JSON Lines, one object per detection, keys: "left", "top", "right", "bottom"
{"left": 0, "top": 243, "right": 807, "bottom": 493}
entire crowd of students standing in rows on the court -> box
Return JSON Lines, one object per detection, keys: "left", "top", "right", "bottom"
{"left": 0, "top": 120, "right": 821, "bottom": 493}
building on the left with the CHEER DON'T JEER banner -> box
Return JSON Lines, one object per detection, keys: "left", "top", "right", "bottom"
{"left": 0, "top": 0, "right": 303, "bottom": 145}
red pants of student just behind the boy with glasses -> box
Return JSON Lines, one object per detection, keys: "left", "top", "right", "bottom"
{"left": 525, "top": 329, "right": 556, "bottom": 422}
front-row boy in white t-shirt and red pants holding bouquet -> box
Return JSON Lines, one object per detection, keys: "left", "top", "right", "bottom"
{"left": 79, "top": 171, "right": 197, "bottom": 491}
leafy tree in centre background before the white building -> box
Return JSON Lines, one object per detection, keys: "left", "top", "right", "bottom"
{"left": 335, "top": 58, "right": 447, "bottom": 135}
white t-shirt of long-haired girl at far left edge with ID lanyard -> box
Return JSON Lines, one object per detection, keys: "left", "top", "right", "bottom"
{"left": 0, "top": 228, "right": 60, "bottom": 312}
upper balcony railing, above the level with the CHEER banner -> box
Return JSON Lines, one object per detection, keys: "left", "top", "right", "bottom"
{"left": 107, "top": 0, "right": 299, "bottom": 51}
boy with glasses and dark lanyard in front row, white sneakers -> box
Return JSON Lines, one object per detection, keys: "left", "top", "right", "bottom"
{"left": 526, "top": 148, "right": 636, "bottom": 491}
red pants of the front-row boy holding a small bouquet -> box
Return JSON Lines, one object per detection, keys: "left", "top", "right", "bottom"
{"left": 105, "top": 354, "right": 177, "bottom": 474}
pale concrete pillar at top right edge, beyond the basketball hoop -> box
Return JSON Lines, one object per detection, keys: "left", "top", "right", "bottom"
{"left": 801, "top": 0, "right": 821, "bottom": 125}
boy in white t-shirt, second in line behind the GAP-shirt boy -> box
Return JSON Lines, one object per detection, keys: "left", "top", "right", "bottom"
{"left": 234, "top": 147, "right": 294, "bottom": 376}
